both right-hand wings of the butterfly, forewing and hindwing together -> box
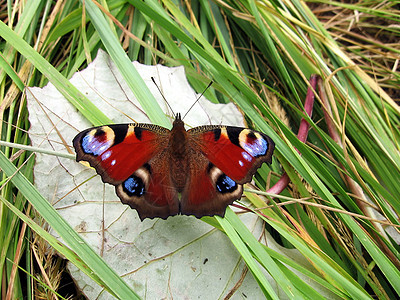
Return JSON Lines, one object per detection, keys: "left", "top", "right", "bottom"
{"left": 181, "top": 126, "right": 275, "bottom": 218}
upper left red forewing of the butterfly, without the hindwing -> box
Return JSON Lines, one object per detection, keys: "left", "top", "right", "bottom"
{"left": 73, "top": 124, "right": 170, "bottom": 185}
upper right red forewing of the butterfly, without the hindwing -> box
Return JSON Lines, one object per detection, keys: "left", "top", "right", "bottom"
{"left": 188, "top": 126, "right": 275, "bottom": 184}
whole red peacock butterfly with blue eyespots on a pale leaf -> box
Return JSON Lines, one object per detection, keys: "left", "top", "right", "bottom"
{"left": 73, "top": 114, "right": 275, "bottom": 220}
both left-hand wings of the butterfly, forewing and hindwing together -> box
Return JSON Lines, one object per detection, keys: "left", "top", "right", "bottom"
{"left": 73, "top": 124, "right": 179, "bottom": 220}
